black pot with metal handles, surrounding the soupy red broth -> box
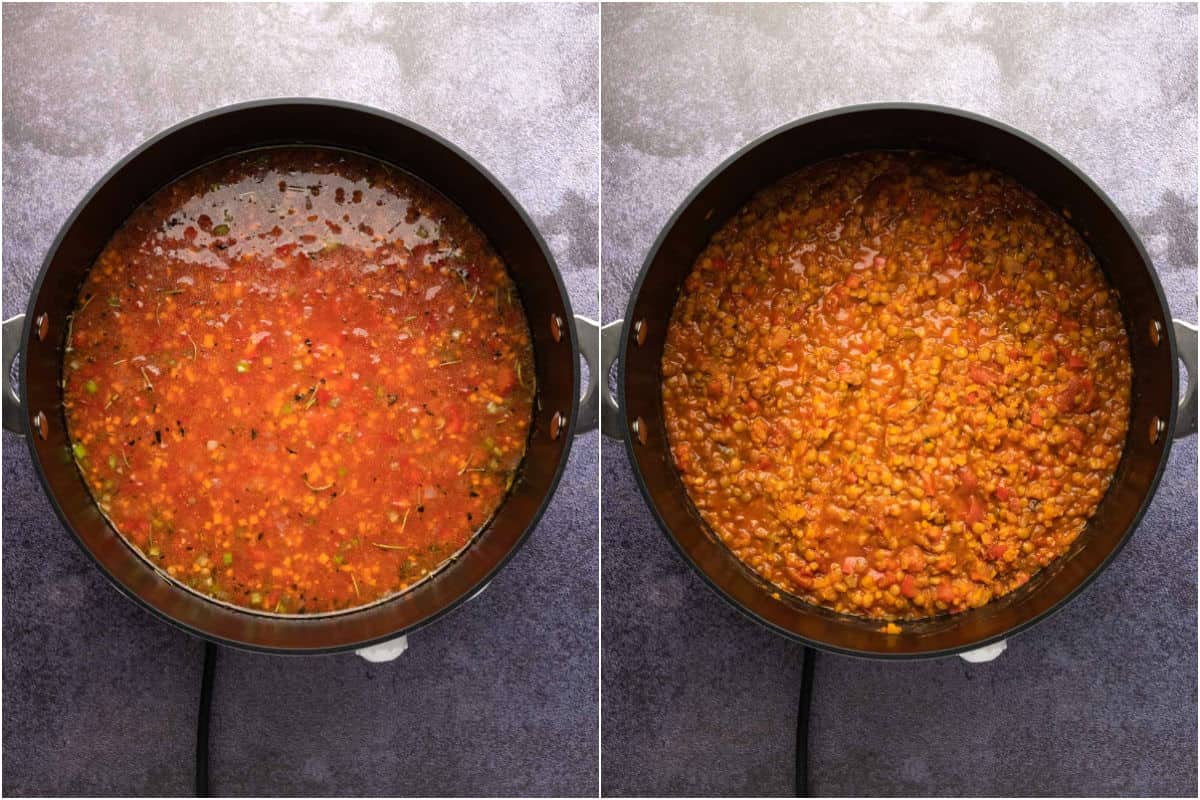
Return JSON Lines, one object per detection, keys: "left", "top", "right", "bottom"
{"left": 4, "top": 100, "right": 599, "bottom": 654}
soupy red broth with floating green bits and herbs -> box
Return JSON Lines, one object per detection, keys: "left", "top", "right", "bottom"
{"left": 64, "top": 148, "right": 534, "bottom": 614}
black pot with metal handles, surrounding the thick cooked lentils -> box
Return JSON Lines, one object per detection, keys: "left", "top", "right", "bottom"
{"left": 601, "top": 103, "right": 1196, "bottom": 658}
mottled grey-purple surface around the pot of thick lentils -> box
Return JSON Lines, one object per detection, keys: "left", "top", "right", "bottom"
{"left": 601, "top": 5, "right": 1196, "bottom": 796}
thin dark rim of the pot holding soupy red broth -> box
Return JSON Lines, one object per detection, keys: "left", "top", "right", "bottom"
{"left": 19, "top": 97, "right": 580, "bottom": 655}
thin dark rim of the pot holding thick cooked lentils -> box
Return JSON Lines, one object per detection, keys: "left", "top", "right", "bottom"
{"left": 617, "top": 102, "right": 1180, "bottom": 661}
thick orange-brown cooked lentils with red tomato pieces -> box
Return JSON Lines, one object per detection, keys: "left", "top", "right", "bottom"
{"left": 662, "top": 152, "right": 1132, "bottom": 632}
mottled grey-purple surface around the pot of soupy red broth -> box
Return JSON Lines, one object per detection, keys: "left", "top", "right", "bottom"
{"left": 2, "top": 5, "right": 599, "bottom": 795}
